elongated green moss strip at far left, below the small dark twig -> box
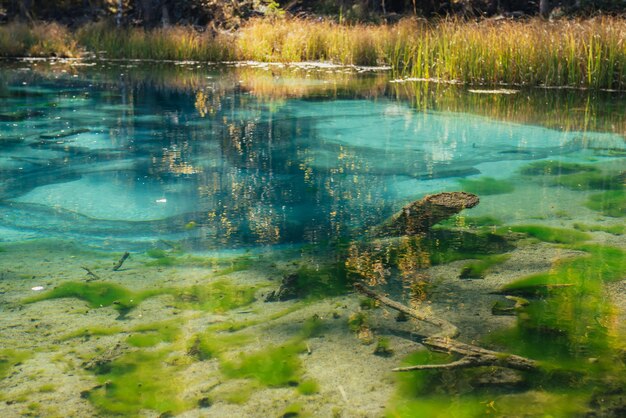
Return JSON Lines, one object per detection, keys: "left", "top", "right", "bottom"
{"left": 24, "top": 282, "right": 163, "bottom": 314}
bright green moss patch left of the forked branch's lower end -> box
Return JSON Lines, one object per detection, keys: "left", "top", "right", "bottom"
{"left": 221, "top": 341, "right": 306, "bottom": 387}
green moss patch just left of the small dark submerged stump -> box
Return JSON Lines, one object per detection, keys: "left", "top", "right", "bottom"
{"left": 169, "top": 280, "right": 257, "bottom": 312}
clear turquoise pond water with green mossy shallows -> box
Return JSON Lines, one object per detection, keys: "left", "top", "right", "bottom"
{"left": 0, "top": 61, "right": 626, "bottom": 416}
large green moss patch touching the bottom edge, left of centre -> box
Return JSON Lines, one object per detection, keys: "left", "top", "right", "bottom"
{"left": 86, "top": 349, "right": 193, "bottom": 416}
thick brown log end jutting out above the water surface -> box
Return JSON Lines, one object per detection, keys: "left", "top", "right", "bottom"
{"left": 371, "top": 192, "right": 479, "bottom": 237}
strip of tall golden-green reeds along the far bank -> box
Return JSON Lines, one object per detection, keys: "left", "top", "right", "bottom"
{"left": 0, "top": 17, "right": 626, "bottom": 90}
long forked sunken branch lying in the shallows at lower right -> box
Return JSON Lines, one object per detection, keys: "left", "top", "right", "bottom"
{"left": 354, "top": 283, "right": 539, "bottom": 372}
